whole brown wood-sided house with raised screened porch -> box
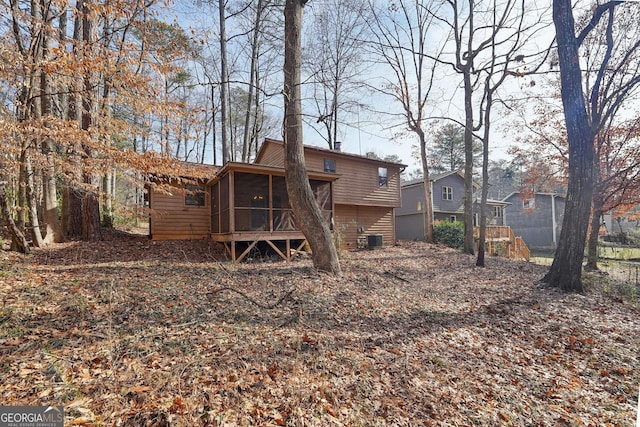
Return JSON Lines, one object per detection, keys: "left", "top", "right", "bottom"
{"left": 148, "top": 139, "right": 405, "bottom": 261}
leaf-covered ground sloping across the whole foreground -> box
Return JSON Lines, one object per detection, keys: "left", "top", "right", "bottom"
{"left": 0, "top": 233, "right": 640, "bottom": 426}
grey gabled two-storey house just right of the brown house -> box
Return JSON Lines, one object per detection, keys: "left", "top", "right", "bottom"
{"left": 396, "top": 171, "right": 508, "bottom": 240}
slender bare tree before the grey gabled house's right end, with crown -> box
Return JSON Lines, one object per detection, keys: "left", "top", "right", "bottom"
{"left": 434, "top": 0, "right": 556, "bottom": 254}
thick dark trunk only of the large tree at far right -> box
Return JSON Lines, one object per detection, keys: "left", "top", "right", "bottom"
{"left": 543, "top": 0, "right": 595, "bottom": 292}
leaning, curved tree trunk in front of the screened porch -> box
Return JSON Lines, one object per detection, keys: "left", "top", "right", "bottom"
{"left": 284, "top": 0, "right": 340, "bottom": 274}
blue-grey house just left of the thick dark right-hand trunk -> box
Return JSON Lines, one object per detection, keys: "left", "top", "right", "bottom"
{"left": 504, "top": 192, "right": 566, "bottom": 249}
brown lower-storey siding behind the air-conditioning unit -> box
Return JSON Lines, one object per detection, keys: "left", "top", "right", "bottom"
{"left": 334, "top": 205, "right": 395, "bottom": 249}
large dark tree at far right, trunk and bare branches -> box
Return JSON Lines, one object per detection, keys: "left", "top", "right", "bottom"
{"left": 543, "top": 0, "right": 640, "bottom": 292}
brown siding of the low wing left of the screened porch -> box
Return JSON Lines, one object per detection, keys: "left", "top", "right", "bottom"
{"left": 150, "top": 187, "right": 210, "bottom": 240}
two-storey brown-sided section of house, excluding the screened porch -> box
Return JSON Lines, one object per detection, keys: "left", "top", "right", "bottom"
{"left": 255, "top": 139, "right": 406, "bottom": 248}
